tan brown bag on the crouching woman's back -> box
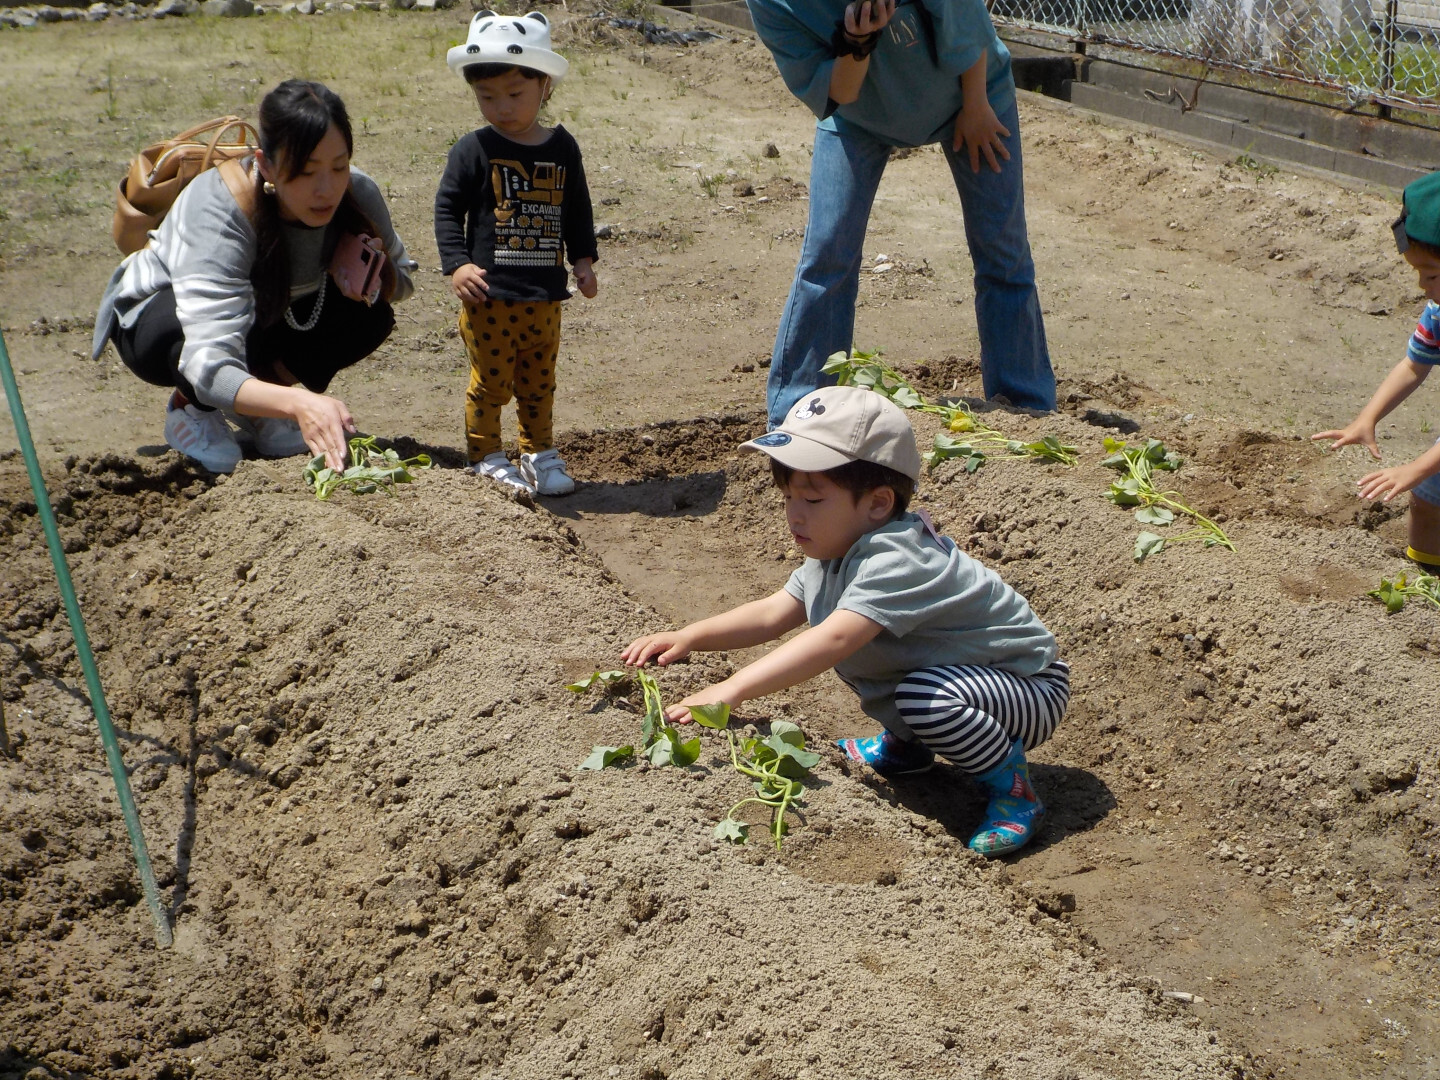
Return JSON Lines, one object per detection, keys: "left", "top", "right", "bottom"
{"left": 109, "top": 117, "right": 259, "bottom": 255}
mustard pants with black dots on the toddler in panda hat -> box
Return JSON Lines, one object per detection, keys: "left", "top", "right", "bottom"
{"left": 459, "top": 300, "right": 560, "bottom": 464}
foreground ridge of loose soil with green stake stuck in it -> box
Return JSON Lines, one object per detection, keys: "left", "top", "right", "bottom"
{"left": 0, "top": 449, "right": 1230, "bottom": 1077}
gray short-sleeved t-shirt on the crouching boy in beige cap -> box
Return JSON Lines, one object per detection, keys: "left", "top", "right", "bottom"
{"left": 785, "top": 514, "right": 1060, "bottom": 733}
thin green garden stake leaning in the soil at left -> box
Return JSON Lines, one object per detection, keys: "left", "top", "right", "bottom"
{"left": 0, "top": 333, "right": 174, "bottom": 948}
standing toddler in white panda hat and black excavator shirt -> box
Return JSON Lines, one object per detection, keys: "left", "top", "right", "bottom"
{"left": 435, "top": 12, "right": 598, "bottom": 495}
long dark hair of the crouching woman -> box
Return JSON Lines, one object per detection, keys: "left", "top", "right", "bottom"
{"left": 251, "top": 79, "right": 377, "bottom": 327}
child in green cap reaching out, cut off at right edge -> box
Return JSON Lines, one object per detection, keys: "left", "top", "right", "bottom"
{"left": 1310, "top": 173, "right": 1440, "bottom": 573}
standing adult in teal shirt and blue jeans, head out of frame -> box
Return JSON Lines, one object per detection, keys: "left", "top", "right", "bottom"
{"left": 747, "top": 0, "right": 1056, "bottom": 428}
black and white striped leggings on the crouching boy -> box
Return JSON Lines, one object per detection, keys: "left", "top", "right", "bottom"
{"left": 896, "top": 660, "right": 1070, "bottom": 773}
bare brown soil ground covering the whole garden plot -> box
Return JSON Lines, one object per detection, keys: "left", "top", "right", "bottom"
{"left": 0, "top": 10, "right": 1440, "bottom": 1080}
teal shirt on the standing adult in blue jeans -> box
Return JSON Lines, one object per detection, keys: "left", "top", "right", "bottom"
{"left": 747, "top": 0, "right": 1015, "bottom": 147}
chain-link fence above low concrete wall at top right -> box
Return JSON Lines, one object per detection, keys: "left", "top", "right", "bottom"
{"left": 991, "top": 0, "right": 1440, "bottom": 112}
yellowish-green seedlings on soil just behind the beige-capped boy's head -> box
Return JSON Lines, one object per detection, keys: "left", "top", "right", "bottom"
{"left": 822, "top": 348, "right": 1080, "bottom": 472}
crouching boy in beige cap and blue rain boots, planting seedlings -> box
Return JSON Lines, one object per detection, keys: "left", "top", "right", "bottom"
{"left": 621, "top": 386, "right": 1070, "bottom": 855}
